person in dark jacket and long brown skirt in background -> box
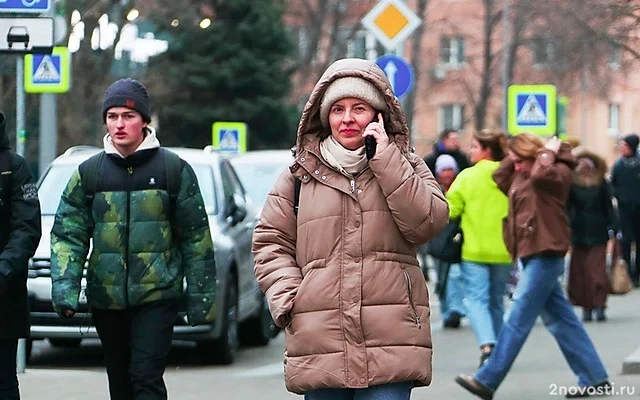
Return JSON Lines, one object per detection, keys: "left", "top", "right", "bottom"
{"left": 567, "top": 151, "right": 618, "bottom": 321}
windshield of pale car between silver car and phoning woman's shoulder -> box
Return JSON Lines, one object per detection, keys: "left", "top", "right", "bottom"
{"left": 231, "top": 160, "right": 291, "bottom": 207}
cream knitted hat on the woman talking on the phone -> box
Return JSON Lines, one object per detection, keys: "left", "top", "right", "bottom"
{"left": 320, "top": 76, "right": 387, "bottom": 126}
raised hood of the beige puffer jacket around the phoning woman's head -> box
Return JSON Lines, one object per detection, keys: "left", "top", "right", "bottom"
{"left": 297, "top": 58, "right": 409, "bottom": 154}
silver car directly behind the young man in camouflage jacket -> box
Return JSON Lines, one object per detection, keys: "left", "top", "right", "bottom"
{"left": 27, "top": 146, "right": 277, "bottom": 364}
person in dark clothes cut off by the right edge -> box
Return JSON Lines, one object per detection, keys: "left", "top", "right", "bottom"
{"left": 611, "top": 134, "right": 640, "bottom": 287}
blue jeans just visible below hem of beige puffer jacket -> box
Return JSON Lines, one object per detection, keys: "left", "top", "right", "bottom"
{"left": 304, "top": 382, "right": 413, "bottom": 400}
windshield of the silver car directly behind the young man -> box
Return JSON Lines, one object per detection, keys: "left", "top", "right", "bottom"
{"left": 38, "top": 164, "right": 218, "bottom": 215}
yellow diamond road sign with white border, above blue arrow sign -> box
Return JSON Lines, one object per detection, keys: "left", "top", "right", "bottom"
{"left": 362, "top": 0, "right": 421, "bottom": 51}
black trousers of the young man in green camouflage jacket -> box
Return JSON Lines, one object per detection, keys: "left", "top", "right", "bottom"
{"left": 93, "top": 302, "right": 178, "bottom": 400}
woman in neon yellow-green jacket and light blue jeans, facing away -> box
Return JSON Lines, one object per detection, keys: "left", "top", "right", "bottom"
{"left": 446, "top": 130, "right": 512, "bottom": 365}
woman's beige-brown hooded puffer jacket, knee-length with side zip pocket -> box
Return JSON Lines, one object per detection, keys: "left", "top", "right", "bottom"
{"left": 253, "top": 59, "right": 449, "bottom": 393}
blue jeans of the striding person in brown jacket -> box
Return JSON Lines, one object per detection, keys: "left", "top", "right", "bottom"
{"left": 475, "top": 256, "right": 607, "bottom": 390}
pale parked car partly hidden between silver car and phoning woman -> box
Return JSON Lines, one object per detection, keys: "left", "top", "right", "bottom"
{"left": 230, "top": 150, "right": 294, "bottom": 213}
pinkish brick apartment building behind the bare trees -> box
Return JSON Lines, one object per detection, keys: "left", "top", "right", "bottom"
{"left": 287, "top": 0, "right": 640, "bottom": 163}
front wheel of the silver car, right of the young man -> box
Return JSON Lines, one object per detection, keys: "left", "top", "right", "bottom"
{"left": 198, "top": 275, "right": 239, "bottom": 365}
